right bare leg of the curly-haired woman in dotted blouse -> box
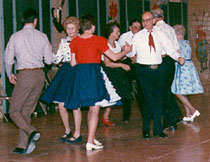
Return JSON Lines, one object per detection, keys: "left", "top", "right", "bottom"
{"left": 73, "top": 108, "right": 82, "bottom": 138}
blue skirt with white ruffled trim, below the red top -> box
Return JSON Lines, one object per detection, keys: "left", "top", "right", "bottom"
{"left": 64, "top": 63, "right": 121, "bottom": 109}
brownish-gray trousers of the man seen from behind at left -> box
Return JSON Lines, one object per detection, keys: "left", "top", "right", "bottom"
{"left": 9, "top": 70, "right": 45, "bottom": 149}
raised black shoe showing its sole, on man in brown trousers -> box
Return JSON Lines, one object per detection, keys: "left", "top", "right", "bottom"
{"left": 26, "top": 131, "right": 40, "bottom": 154}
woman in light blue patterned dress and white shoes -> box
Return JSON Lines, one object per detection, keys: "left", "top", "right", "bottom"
{"left": 171, "top": 25, "right": 204, "bottom": 121}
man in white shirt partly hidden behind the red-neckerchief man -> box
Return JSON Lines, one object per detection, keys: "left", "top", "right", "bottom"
{"left": 151, "top": 8, "right": 181, "bottom": 131}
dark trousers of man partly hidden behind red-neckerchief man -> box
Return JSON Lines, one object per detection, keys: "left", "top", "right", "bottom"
{"left": 160, "top": 56, "right": 181, "bottom": 128}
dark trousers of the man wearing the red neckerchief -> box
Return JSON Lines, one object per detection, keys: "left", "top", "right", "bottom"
{"left": 136, "top": 64, "right": 162, "bottom": 135}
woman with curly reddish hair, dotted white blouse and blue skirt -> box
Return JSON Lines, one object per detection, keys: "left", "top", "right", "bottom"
{"left": 41, "top": 16, "right": 82, "bottom": 143}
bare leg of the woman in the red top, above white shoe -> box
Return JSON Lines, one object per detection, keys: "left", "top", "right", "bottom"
{"left": 87, "top": 106, "right": 100, "bottom": 144}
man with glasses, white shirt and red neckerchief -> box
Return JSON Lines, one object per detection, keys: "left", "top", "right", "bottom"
{"left": 132, "top": 11, "right": 184, "bottom": 139}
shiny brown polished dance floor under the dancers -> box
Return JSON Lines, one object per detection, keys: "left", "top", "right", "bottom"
{"left": 0, "top": 93, "right": 210, "bottom": 162}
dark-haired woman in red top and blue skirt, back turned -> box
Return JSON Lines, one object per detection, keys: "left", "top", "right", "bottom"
{"left": 64, "top": 14, "right": 132, "bottom": 150}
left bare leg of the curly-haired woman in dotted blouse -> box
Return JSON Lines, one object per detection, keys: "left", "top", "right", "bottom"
{"left": 58, "top": 103, "right": 71, "bottom": 134}
